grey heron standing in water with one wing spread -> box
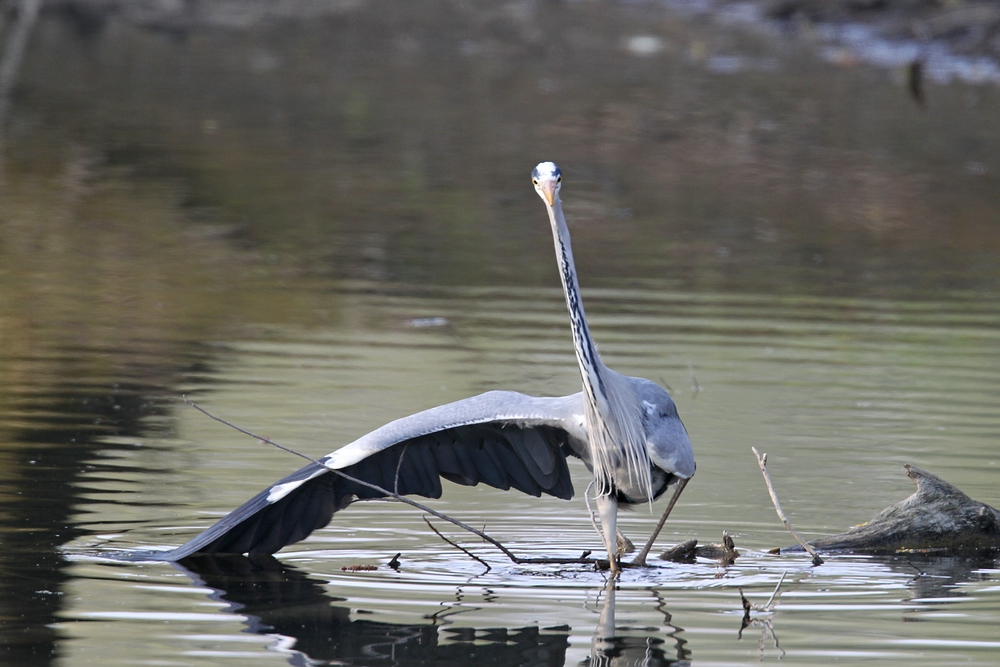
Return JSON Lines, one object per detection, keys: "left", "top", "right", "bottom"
{"left": 160, "top": 162, "right": 695, "bottom": 572}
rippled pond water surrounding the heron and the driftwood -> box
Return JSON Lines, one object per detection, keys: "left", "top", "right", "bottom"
{"left": 0, "top": 2, "right": 1000, "bottom": 665}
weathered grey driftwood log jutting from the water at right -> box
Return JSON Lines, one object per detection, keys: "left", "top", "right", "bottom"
{"left": 782, "top": 465, "right": 1000, "bottom": 556}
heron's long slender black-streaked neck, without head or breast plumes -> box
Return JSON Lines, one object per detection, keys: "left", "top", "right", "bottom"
{"left": 549, "top": 195, "right": 607, "bottom": 407}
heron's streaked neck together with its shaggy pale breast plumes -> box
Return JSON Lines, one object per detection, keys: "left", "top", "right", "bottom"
{"left": 549, "top": 198, "right": 653, "bottom": 502}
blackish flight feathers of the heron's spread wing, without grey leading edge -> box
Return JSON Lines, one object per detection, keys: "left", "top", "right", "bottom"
{"left": 148, "top": 423, "right": 573, "bottom": 561}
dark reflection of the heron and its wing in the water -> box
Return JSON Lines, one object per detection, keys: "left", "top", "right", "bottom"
{"left": 175, "top": 555, "right": 688, "bottom": 667}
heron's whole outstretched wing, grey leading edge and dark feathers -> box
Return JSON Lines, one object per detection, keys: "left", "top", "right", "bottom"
{"left": 157, "top": 391, "right": 586, "bottom": 561}
